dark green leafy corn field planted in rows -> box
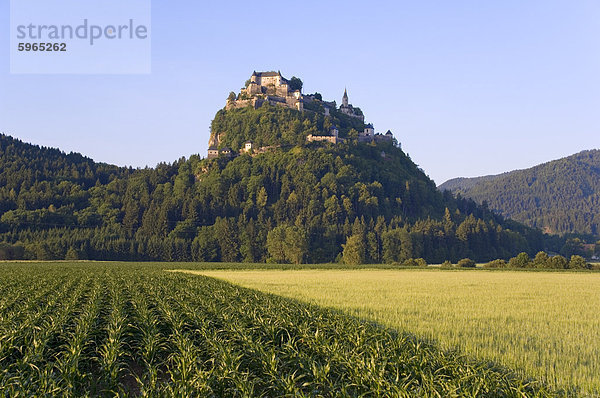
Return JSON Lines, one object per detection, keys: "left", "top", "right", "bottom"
{"left": 0, "top": 263, "right": 555, "bottom": 397}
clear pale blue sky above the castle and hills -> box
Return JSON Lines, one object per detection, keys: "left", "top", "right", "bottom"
{"left": 0, "top": 0, "right": 600, "bottom": 184}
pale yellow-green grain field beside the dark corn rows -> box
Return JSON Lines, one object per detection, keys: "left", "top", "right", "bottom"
{"left": 188, "top": 269, "right": 600, "bottom": 396}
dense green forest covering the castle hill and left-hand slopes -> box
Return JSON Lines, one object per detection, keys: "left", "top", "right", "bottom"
{"left": 0, "top": 105, "right": 561, "bottom": 263}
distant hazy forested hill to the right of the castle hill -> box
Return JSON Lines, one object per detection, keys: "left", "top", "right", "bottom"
{"left": 439, "top": 150, "right": 600, "bottom": 236}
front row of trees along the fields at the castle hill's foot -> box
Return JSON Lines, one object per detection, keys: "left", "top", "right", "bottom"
{"left": 4, "top": 208, "right": 544, "bottom": 263}
